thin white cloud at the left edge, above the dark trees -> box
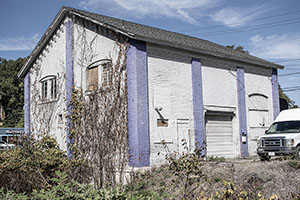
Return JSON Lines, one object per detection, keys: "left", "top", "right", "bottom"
{"left": 0, "top": 33, "right": 40, "bottom": 51}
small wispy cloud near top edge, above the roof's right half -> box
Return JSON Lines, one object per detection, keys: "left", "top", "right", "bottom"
{"left": 211, "top": 6, "right": 266, "bottom": 27}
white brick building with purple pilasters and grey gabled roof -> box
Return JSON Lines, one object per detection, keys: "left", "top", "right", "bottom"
{"left": 19, "top": 7, "right": 283, "bottom": 167}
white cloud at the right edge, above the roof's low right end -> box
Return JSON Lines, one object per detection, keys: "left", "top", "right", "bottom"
{"left": 250, "top": 34, "right": 300, "bottom": 60}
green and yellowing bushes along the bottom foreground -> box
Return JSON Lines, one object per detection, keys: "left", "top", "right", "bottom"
{"left": 0, "top": 137, "right": 300, "bottom": 200}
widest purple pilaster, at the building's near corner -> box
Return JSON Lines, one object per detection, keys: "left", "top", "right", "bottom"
{"left": 127, "top": 40, "right": 150, "bottom": 167}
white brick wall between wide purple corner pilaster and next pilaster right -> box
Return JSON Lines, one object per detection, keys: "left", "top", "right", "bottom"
{"left": 147, "top": 44, "right": 194, "bottom": 165}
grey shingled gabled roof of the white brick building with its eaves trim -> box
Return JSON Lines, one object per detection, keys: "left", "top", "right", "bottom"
{"left": 18, "top": 7, "right": 284, "bottom": 77}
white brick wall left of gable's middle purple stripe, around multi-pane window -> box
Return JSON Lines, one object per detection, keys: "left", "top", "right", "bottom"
{"left": 30, "top": 19, "right": 66, "bottom": 150}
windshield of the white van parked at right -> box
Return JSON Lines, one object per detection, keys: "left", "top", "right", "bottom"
{"left": 266, "top": 121, "right": 300, "bottom": 134}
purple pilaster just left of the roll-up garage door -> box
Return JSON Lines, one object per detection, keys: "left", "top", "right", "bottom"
{"left": 192, "top": 58, "right": 206, "bottom": 155}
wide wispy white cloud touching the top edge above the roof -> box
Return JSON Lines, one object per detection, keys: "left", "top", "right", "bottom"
{"left": 80, "top": 0, "right": 219, "bottom": 24}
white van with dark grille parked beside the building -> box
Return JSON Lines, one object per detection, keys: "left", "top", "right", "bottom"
{"left": 257, "top": 108, "right": 300, "bottom": 160}
